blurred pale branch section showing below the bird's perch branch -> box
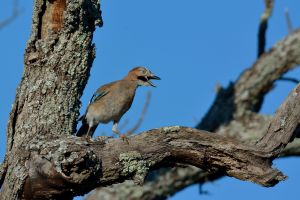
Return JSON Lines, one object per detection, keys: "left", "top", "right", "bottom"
{"left": 86, "top": 166, "right": 223, "bottom": 200}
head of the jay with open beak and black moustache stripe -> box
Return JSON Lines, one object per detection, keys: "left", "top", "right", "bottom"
{"left": 126, "top": 67, "right": 160, "bottom": 87}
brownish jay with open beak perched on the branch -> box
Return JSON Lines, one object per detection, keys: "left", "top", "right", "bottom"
{"left": 76, "top": 66, "right": 161, "bottom": 138}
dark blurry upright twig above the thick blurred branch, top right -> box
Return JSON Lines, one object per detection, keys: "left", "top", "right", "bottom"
{"left": 257, "top": 0, "right": 274, "bottom": 58}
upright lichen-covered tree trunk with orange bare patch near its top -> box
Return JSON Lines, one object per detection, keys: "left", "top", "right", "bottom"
{"left": 0, "top": 0, "right": 102, "bottom": 200}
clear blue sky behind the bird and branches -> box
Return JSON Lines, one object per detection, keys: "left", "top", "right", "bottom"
{"left": 0, "top": 0, "right": 300, "bottom": 200}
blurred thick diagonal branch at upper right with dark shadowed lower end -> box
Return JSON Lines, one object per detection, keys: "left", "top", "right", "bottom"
{"left": 196, "top": 30, "right": 300, "bottom": 131}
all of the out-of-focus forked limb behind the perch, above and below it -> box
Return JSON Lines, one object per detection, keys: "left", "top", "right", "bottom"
{"left": 88, "top": 30, "right": 300, "bottom": 200}
